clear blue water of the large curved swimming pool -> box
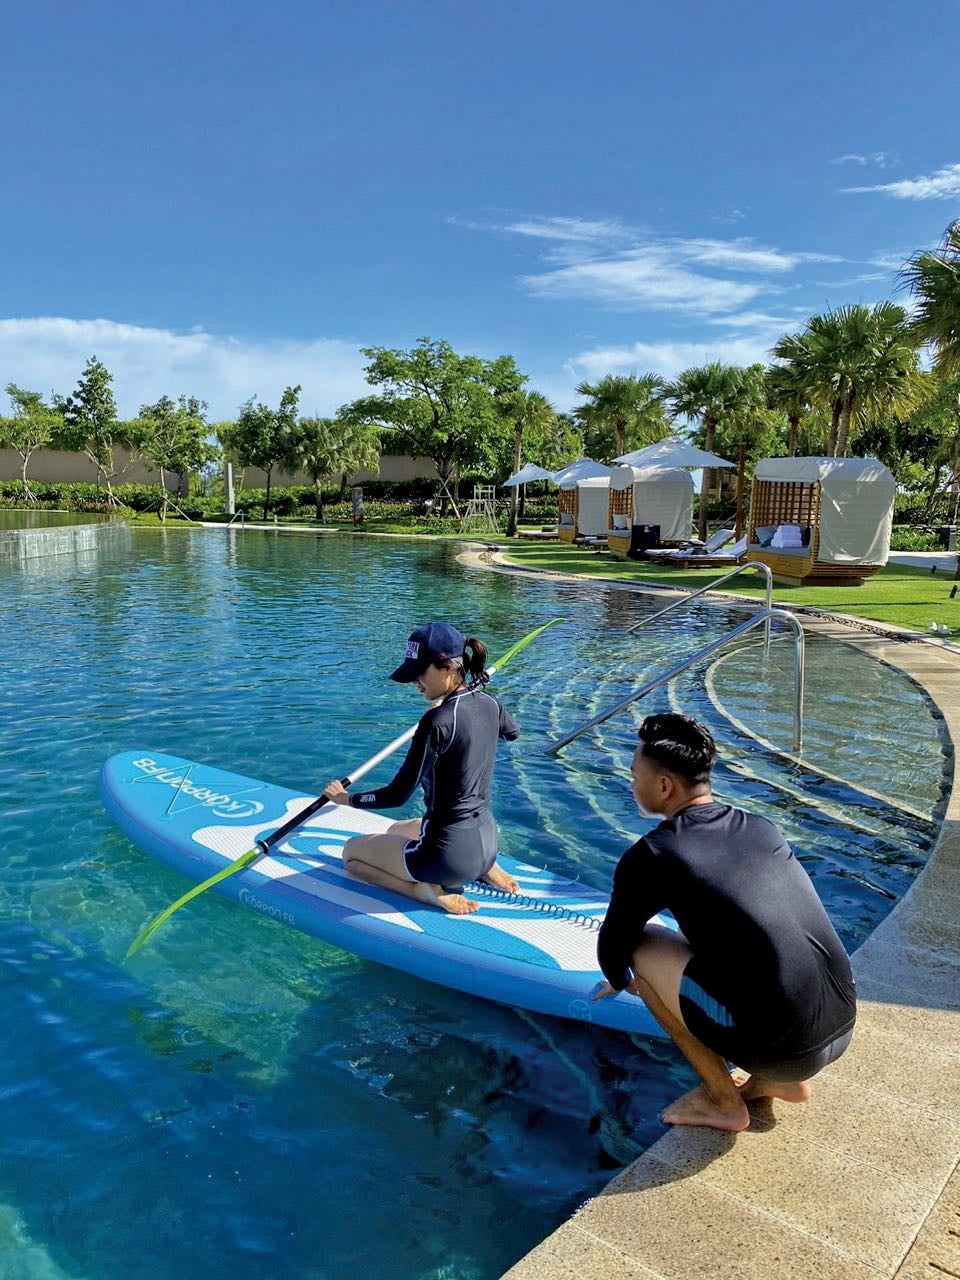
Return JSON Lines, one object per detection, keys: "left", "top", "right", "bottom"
{"left": 0, "top": 530, "right": 943, "bottom": 1280}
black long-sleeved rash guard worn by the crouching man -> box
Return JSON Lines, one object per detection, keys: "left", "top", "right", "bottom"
{"left": 598, "top": 801, "right": 856, "bottom": 1056}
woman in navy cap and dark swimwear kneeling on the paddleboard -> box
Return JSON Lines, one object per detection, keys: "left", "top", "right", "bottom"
{"left": 324, "top": 622, "right": 520, "bottom": 915}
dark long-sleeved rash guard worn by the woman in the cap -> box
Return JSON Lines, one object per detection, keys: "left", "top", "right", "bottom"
{"left": 349, "top": 689, "right": 520, "bottom": 826}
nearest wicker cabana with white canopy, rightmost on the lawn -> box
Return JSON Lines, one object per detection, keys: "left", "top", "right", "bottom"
{"left": 748, "top": 458, "right": 896, "bottom": 586}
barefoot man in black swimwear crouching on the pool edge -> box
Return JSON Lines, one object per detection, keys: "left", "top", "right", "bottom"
{"left": 594, "top": 716, "right": 856, "bottom": 1133}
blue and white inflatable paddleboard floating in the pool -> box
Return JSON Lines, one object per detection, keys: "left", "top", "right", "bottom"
{"left": 100, "top": 751, "right": 663, "bottom": 1037}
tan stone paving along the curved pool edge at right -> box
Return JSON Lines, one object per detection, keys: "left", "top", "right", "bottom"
{"left": 484, "top": 557, "right": 960, "bottom": 1280}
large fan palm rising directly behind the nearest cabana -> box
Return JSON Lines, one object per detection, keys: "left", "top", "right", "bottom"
{"left": 803, "top": 302, "right": 918, "bottom": 458}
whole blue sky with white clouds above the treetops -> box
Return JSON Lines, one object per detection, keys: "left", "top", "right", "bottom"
{"left": 0, "top": 0, "right": 960, "bottom": 419}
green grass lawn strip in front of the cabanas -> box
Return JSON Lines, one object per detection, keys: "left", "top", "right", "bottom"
{"left": 484, "top": 538, "right": 960, "bottom": 636}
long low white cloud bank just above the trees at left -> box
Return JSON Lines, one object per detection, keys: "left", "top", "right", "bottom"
{"left": 0, "top": 316, "right": 370, "bottom": 421}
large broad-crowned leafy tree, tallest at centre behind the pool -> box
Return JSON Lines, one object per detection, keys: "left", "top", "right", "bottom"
{"left": 340, "top": 338, "right": 526, "bottom": 517}
